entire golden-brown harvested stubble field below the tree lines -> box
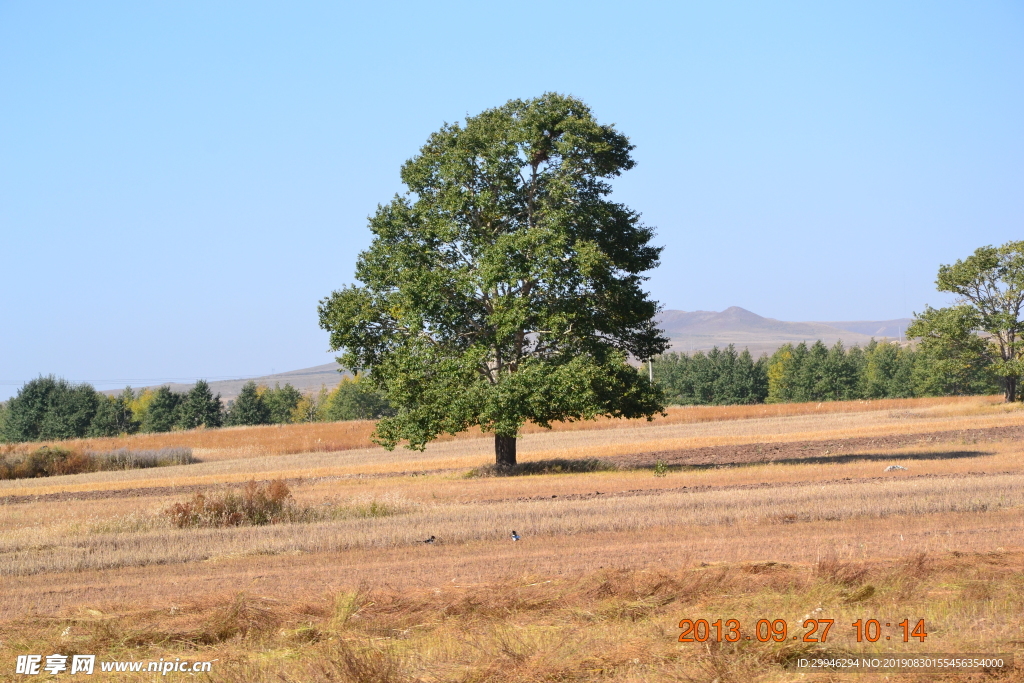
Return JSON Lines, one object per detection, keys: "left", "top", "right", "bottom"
{"left": 0, "top": 398, "right": 1024, "bottom": 683}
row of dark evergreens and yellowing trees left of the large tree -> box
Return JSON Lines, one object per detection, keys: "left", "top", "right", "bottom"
{"left": 0, "top": 376, "right": 392, "bottom": 442}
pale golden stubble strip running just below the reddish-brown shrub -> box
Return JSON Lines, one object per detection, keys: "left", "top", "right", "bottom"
{"left": 8, "top": 466, "right": 1024, "bottom": 575}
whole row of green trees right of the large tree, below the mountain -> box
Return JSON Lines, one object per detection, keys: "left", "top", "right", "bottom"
{"left": 651, "top": 340, "right": 999, "bottom": 405}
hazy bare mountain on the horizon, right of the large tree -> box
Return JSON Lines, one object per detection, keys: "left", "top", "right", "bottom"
{"left": 658, "top": 306, "right": 909, "bottom": 356}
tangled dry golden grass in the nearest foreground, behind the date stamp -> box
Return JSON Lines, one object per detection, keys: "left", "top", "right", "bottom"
{"left": 0, "top": 552, "right": 1024, "bottom": 683}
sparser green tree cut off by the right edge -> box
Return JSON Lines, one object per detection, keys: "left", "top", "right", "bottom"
{"left": 907, "top": 242, "right": 1024, "bottom": 401}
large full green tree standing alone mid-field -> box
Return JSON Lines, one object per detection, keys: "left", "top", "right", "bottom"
{"left": 319, "top": 93, "right": 668, "bottom": 465}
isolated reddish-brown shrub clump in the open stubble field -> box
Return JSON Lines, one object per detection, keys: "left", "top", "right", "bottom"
{"left": 165, "top": 479, "right": 304, "bottom": 528}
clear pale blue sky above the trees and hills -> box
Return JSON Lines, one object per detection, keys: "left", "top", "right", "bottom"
{"left": 0, "top": 0, "right": 1024, "bottom": 398}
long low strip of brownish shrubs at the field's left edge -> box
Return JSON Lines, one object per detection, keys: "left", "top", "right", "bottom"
{"left": 0, "top": 445, "right": 197, "bottom": 479}
